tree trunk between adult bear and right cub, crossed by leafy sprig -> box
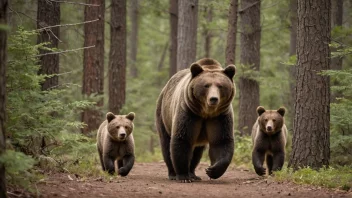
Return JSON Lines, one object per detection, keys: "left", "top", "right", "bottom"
{"left": 238, "top": 0, "right": 261, "bottom": 135}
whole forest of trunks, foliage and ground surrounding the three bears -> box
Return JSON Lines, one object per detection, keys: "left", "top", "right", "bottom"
{"left": 0, "top": 0, "right": 352, "bottom": 197}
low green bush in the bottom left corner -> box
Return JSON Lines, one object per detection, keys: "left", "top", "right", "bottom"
{"left": 0, "top": 150, "right": 40, "bottom": 190}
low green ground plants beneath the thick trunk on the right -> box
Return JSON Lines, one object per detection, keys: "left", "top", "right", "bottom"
{"left": 275, "top": 166, "right": 352, "bottom": 191}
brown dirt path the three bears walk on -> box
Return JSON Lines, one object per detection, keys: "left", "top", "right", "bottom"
{"left": 9, "top": 162, "right": 352, "bottom": 198}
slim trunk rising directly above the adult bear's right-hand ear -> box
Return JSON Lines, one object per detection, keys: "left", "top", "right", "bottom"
{"left": 225, "top": 0, "right": 238, "bottom": 65}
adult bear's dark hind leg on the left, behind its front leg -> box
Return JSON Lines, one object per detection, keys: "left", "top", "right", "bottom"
{"left": 156, "top": 119, "right": 176, "bottom": 180}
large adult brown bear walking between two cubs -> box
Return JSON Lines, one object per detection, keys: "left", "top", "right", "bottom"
{"left": 156, "top": 58, "right": 236, "bottom": 182}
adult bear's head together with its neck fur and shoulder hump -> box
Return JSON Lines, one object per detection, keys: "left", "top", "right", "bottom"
{"left": 188, "top": 59, "right": 236, "bottom": 117}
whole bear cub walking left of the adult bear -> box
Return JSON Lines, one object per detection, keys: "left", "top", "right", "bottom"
{"left": 97, "top": 112, "right": 135, "bottom": 176}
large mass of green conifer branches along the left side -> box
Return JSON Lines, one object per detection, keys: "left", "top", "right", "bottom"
{"left": 1, "top": 28, "right": 94, "bottom": 188}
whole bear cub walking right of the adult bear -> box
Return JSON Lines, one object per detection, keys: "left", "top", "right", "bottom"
{"left": 252, "top": 106, "right": 287, "bottom": 176}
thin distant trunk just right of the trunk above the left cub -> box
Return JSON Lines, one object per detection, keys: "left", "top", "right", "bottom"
{"left": 130, "top": 0, "right": 139, "bottom": 78}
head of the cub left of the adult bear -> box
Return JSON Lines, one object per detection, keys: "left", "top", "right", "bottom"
{"left": 106, "top": 112, "right": 135, "bottom": 141}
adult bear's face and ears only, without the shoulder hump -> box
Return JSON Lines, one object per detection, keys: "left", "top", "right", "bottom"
{"left": 191, "top": 64, "right": 236, "bottom": 108}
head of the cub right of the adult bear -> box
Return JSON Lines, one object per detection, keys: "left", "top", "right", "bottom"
{"left": 257, "top": 106, "right": 285, "bottom": 135}
